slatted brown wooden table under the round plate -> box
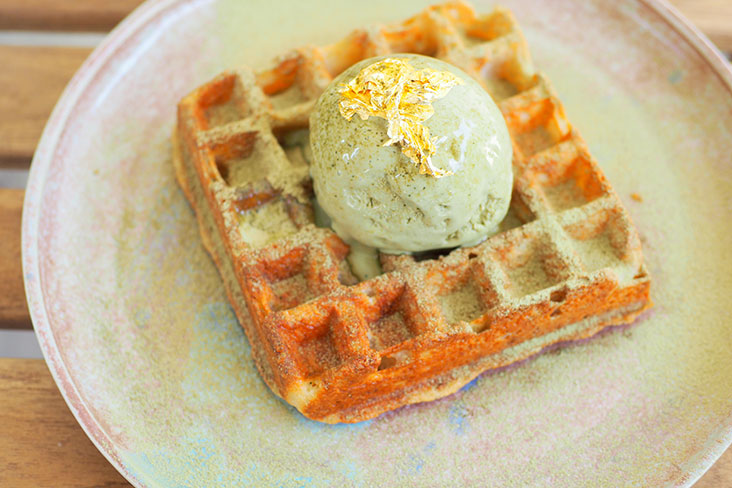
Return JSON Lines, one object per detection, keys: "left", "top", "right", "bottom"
{"left": 0, "top": 0, "right": 732, "bottom": 488}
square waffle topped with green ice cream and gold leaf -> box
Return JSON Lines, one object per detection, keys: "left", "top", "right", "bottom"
{"left": 173, "top": 2, "right": 651, "bottom": 423}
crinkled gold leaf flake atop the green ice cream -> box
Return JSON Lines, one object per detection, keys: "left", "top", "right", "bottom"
{"left": 338, "top": 58, "right": 463, "bottom": 178}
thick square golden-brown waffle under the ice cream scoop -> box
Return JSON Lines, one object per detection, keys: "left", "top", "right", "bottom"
{"left": 173, "top": 2, "right": 651, "bottom": 423}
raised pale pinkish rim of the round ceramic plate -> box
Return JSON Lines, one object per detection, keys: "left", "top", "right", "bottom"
{"left": 21, "top": 0, "right": 732, "bottom": 488}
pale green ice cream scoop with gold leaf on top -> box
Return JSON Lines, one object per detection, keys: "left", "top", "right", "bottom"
{"left": 310, "top": 54, "right": 513, "bottom": 253}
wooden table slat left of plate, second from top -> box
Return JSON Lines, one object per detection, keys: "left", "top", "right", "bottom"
{"left": 0, "top": 45, "right": 90, "bottom": 168}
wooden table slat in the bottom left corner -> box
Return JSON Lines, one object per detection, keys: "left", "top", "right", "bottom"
{"left": 0, "top": 358, "right": 131, "bottom": 488}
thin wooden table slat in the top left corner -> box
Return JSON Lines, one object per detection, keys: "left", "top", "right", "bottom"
{"left": 0, "top": 0, "right": 142, "bottom": 32}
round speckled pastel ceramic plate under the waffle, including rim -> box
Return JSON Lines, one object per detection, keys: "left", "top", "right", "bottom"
{"left": 23, "top": 0, "right": 732, "bottom": 487}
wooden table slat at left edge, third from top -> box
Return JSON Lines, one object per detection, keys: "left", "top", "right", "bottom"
{"left": 0, "top": 188, "right": 31, "bottom": 330}
